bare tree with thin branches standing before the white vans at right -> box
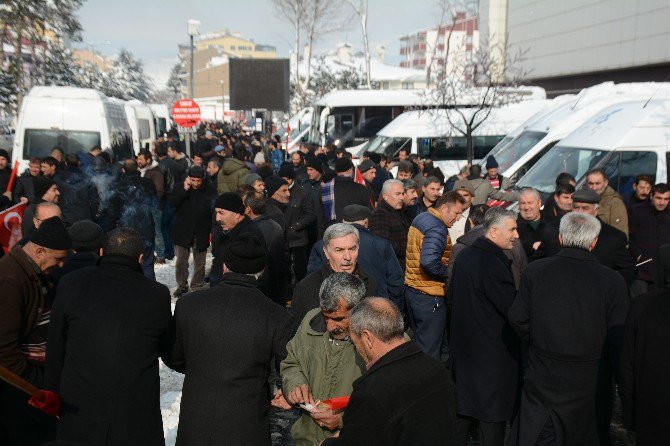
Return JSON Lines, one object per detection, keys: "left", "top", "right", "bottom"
{"left": 427, "top": 30, "right": 528, "bottom": 163}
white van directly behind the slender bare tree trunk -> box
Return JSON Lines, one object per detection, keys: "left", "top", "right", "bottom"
{"left": 358, "top": 100, "right": 551, "bottom": 177}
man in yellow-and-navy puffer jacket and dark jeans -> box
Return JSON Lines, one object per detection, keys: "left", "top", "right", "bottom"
{"left": 405, "top": 191, "right": 465, "bottom": 359}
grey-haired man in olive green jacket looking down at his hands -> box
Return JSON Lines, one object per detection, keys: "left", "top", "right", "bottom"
{"left": 280, "top": 273, "right": 365, "bottom": 446}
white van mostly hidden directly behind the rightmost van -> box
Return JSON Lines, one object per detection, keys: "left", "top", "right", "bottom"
{"left": 495, "top": 82, "right": 670, "bottom": 183}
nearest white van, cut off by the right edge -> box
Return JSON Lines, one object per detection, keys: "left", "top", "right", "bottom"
{"left": 517, "top": 99, "right": 670, "bottom": 194}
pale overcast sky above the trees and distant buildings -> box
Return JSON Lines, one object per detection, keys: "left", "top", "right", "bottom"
{"left": 74, "top": 0, "right": 439, "bottom": 87}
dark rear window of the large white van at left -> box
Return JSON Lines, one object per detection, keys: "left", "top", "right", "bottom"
{"left": 23, "top": 129, "right": 100, "bottom": 159}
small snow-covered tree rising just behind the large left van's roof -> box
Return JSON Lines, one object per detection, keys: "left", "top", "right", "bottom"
{"left": 105, "top": 48, "right": 151, "bottom": 101}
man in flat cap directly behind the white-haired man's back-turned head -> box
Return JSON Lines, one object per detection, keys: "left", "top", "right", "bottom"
{"left": 536, "top": 189, "right": 635, "bottom": 286}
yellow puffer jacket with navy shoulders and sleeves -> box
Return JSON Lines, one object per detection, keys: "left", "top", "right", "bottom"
{"left": 405, "top": 208, "right": 451, "bottom": 297}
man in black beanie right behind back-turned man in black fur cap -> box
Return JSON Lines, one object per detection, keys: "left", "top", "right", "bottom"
{"left": 209, "top": 192, "right": 268, "bottom": 294}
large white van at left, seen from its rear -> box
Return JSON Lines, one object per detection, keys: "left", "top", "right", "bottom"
{"left": 13, "top": 87, "right": 134, "bottom": 169}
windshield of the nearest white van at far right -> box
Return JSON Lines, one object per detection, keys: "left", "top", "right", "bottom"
{"left": 516, "top": 146, "right": 608, "bottom": 193}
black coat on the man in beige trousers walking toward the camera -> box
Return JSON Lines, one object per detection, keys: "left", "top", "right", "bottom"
{"left": 168, "top": 182, "right": 216, "bottom": 252}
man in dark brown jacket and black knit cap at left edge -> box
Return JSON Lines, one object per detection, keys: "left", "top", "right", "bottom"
{"left": 0, "top": 217, "right": 72, "bottom": 445}
